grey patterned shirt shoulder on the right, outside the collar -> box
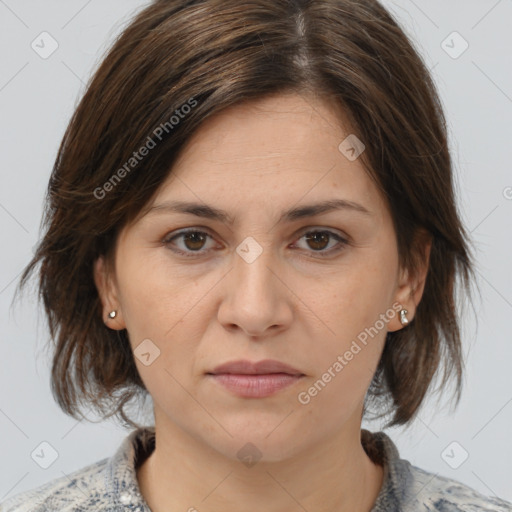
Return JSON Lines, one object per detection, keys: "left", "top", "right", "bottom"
{"left": 400, "top": 460, "right": 512, "bottom": 512}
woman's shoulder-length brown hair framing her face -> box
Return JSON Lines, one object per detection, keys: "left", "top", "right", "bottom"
{"left": 13, "top": 0, "right": 473, "bottom": 426}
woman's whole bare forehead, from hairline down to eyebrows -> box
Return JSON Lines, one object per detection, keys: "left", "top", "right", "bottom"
{"left": 132, "top": 94, "right": 385, "bottom": 228}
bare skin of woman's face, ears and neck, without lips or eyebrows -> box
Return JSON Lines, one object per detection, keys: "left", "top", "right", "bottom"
{"left": 95, "top": 94, "right": 429, "bottom": 512}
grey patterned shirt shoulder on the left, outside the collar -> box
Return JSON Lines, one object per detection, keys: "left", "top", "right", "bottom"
{"left": 0, "top": 458, "right": 108, "bottom": 512}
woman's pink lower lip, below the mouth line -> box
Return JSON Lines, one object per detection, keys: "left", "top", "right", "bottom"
{"left": 210, "top": 373, "right": 303, "bottom": 398}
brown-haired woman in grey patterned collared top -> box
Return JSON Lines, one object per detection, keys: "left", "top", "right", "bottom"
{"left": 2, "top": 0, "right": 512, "bottom": 512}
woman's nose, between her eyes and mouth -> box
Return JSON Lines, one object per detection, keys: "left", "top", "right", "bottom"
{"left": 218, "top": 245, "right": 294, "bottom": 338}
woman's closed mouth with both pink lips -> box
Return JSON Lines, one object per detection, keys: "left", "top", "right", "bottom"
{"left": 207, "top": 359, "right": 305, "bottom": 398}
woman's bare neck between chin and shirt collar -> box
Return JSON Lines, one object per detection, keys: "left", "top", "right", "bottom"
{"left": 137, "top": 415, "right": 383, "bottom": 512}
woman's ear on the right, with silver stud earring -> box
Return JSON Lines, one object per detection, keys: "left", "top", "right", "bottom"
{"left": 388, "top": 228, "right": 432, "bottom": 332}
